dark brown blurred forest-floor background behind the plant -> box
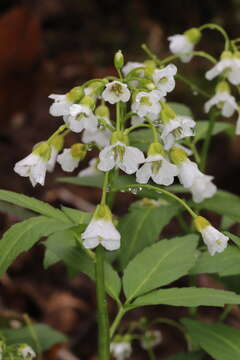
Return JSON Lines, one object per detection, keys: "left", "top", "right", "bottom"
{"left": 0, "top": 0, "right": 240, "bottom": 359}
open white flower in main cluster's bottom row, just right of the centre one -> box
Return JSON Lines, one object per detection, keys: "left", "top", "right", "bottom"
{"left": 136, "top": 154, "right": 178, "bottom": 186}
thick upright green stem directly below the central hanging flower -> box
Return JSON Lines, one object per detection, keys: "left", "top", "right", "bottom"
{"left": 95, "top": 245, "right": 110, "bottom": 360}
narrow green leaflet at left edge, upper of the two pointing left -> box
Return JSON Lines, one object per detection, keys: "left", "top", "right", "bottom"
{"left": 0, "top": 190, "right": 67, "bottom": 222}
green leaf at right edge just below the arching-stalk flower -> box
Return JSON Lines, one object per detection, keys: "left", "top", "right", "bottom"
{"left": 190, "top": 245, "right": 240, "bottom": 276}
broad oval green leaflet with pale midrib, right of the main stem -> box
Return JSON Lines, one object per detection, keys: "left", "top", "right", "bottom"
{"left": 123, "top": 235, "right": 198, "bottom": 302}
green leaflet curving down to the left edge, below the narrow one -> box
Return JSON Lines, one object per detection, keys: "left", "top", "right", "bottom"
{"left": 0, "top": 216, "right": 72, "bottom": 276}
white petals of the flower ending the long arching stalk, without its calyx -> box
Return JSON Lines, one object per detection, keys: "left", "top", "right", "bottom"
{"left": 201, "top": 225, "right": 229, "bottom": 255}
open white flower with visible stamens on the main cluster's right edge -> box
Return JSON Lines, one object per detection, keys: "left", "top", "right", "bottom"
{"left": 161, "top": 116, "right": 196, "bottom": 150}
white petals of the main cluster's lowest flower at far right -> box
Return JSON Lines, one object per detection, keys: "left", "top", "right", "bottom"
{"left": 189, "top": 173, "right": 217, "bottom": 203}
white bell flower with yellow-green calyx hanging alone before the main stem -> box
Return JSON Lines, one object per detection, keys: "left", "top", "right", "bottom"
{"left": 81, "top": 205, "right": 121, "bottom": 251}
